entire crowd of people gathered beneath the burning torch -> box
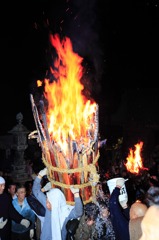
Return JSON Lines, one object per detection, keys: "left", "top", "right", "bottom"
{"left": 0, "top": 160, "right": 159, "bottom": 240}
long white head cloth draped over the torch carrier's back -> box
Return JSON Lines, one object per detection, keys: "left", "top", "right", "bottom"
{"left": 47, "top": 188, "right": 74, "bottom": 240}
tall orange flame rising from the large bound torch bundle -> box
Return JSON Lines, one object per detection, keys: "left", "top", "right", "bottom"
{"left": 38, "top": 34, "right": 97, "bottom": 153}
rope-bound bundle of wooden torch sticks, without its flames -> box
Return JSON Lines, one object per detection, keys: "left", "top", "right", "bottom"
{"left": 30, "top": 95, "right": 99, "bottom": 205}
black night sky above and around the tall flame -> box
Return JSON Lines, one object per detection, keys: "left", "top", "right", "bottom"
{"left": 0, "top": 0, "right": 159, "bottom": 134}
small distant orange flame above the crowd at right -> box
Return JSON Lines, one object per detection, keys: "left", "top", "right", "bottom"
{"left": 125, "top": 142, "right": 145, "bottom": 174}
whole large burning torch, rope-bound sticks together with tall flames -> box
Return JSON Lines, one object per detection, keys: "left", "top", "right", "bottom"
{"left": 30, "top": 35, "right": 99, "bottom": 204}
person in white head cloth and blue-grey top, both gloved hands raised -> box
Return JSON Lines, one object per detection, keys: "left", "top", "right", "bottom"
{"left": 32, "top": 168, "right": 83, "bottom": 240}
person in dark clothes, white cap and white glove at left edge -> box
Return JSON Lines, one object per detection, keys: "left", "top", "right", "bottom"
{"left": 0, "top": 177, "right": 30, "bottom": 240}
